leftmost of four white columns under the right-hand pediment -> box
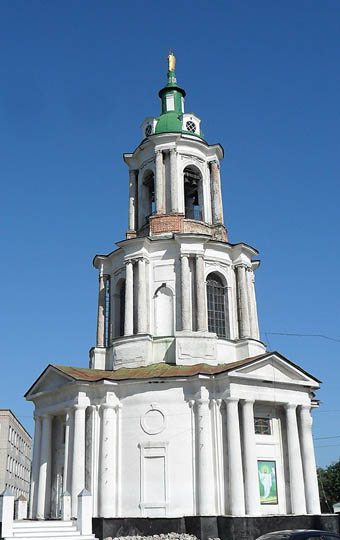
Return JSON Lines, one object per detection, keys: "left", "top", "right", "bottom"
{"left": 225, "top": 397, "right": 244, "bottom": 516}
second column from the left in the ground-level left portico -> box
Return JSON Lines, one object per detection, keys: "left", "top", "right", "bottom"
{"left": 37, "top": 414, "right": 53, "bottom": 519}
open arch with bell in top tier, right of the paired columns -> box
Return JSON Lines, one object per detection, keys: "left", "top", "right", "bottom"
{"left": 183, "top": 165, "right": 203, "bottom": 220}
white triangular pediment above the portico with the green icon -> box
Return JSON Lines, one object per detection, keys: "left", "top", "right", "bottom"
{"left": 229, "top": 353, "right": 320, "bottom": 388}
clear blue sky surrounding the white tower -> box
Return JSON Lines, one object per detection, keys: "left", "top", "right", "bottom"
{"left": 0, "top": 0, "right": 340, "bottom": 465}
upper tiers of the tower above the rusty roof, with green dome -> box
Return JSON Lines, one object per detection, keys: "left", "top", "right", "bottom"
{"left": 90, "top": 53, "right": 265, "bottom": 369}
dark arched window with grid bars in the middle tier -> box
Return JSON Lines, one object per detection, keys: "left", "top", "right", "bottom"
{"left": 207, "top": 274, "right": 229, "bottom": 337}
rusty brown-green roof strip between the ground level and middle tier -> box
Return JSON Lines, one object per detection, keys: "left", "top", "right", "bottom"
{"left": 52, "top": 354, "right": 268, "bottom": 382}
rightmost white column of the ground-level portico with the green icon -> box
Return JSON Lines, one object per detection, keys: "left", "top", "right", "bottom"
{"left": 299, "top": 405, "right": 321, "bottom": 514}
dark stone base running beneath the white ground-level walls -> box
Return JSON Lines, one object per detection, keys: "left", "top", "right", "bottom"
{"left": 92, "top": 514, "right": 340, "bottom": 540}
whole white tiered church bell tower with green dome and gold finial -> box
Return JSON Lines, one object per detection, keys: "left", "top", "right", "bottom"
{"left": 26, "top": 54, "right": 320, "bottom": 518}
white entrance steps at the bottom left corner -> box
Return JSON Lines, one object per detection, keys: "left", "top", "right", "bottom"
{"left": 4, "top": 520, "right": 96, "bottom": 540}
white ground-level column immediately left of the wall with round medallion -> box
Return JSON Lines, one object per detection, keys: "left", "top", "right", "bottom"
{"left": 99, "top": 403, "right": 116, "bottom": 518}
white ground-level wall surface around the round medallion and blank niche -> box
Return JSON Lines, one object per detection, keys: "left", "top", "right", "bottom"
{"left": 121, "top": 382, "right": 194, "bottom": 516}
